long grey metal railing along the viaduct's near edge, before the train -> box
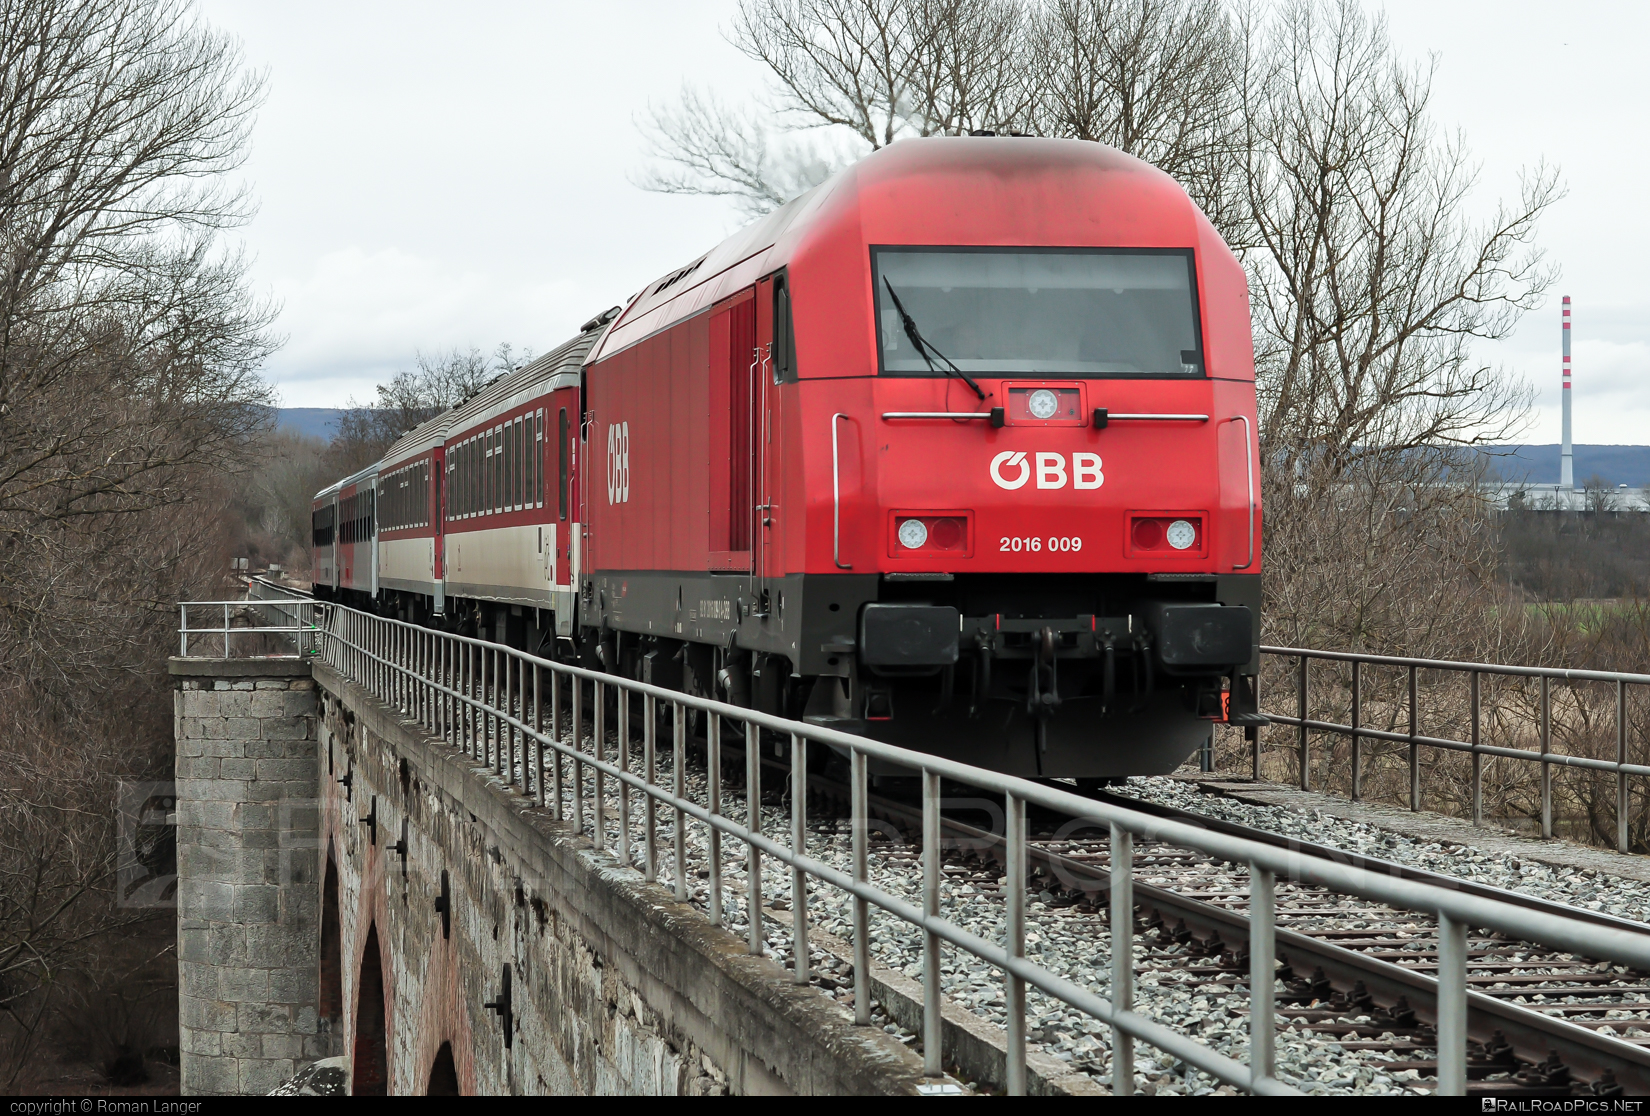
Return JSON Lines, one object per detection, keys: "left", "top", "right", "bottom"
{"left": 174, "top": 603, "right": 1650, "bottom": 1095}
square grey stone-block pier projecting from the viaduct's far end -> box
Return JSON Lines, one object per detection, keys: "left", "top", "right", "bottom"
{"left": 170, "top": 659, "right": 321, "bottom": 1095}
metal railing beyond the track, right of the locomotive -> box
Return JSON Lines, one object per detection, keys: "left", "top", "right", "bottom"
{"left": 1249, "top": 647, "right": 1650, "bottom": 852}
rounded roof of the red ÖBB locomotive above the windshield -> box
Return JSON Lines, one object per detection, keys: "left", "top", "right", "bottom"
{"left": 589, "top": 135, "right": 1213, "bottom": 363}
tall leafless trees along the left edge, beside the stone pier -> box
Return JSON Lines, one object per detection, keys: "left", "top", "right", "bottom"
{"left": 0, "top": 0, "right": 276, "bottom": 1081}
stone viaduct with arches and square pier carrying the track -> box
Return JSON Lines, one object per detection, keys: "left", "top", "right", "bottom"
{"left": 172, "top": 657, "right": 967, "bottom": 1095}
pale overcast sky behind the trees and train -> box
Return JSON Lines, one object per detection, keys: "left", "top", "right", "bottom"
{"left": 201, "top": 0, "right": 1650, "bottom": 444}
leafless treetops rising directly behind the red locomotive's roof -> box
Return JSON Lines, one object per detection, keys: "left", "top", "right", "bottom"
{"left": 637, "top": 0, "right": 1241, "bottom": 228}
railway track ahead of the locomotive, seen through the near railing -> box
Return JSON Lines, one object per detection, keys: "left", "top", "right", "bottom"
{"left": 825, "top": 779, "right": 1650, "bottom": 1098}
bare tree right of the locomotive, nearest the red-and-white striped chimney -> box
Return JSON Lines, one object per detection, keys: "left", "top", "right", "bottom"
{"left": 1242, "top": 0, "right": 1558, "bottom": 655}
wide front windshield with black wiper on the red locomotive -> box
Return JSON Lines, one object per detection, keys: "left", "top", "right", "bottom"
{"left": 871, "top": 248, "right": 1203, "bottom": 376}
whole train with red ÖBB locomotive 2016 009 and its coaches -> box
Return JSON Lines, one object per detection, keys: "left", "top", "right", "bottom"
{"left": 314, "top": 137, "right": 1261, "bottom": 779}
